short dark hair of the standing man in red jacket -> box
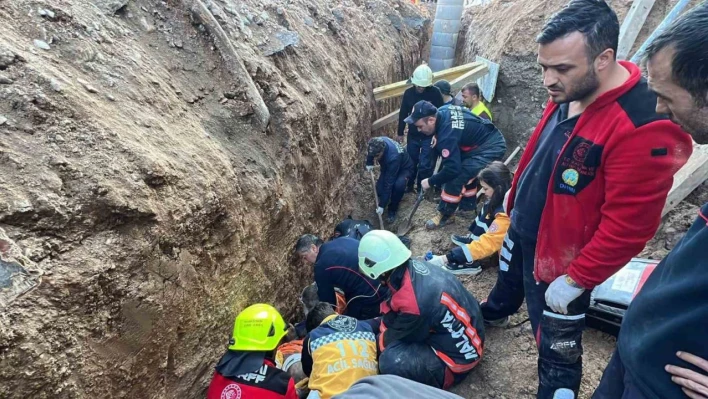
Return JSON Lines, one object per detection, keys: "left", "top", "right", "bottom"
{"left": 536, "top": 0, "right": 619, "bottom": 62}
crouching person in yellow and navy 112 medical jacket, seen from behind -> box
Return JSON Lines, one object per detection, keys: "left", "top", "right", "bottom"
{"left": 302, "top": 302, "right": 378, "bottom": 399}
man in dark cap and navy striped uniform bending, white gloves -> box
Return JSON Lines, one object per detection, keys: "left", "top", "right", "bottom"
{"left": 406, "top": 101, "right": 506, "bottom": 230}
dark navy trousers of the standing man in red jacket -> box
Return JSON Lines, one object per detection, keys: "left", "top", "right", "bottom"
{"left": 481, "top": 227, "right": 591, "bottom": 399}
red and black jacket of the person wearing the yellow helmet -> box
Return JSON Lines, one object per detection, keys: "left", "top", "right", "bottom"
{"left": 207, "top": 351, "right": 298, "bottom": 399}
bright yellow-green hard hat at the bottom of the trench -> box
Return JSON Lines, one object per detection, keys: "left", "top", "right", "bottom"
{"left": 229, "top": 303, "right": 287, "bottom": 351}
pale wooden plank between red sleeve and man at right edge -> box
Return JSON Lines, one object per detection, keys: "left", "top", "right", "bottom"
{"left": 661, "top": 144, "right": 708, "bottom": 217}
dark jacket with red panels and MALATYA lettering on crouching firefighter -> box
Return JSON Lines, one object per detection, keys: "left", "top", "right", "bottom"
{"left": 378, "top": 260, "right": 484, "bottom": 387}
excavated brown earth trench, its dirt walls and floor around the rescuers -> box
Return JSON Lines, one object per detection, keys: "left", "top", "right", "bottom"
{"left": 0, "top": 0, "right": 708, "bottom": 399}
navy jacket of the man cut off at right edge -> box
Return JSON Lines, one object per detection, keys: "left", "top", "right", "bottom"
{"left": 617, "top": 203, "right": 708, "bottom": 399}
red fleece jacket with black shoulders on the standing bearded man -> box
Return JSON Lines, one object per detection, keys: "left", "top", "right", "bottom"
{"left": 507, "top": 61, "right": 692, "bottom": 289}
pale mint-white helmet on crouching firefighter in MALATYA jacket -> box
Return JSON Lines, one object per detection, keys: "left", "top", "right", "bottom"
{"left": 359, "top": 230, "right": 411, "bottom": 279}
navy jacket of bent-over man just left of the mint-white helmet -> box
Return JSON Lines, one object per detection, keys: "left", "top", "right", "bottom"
{"left": 315, "top": 237, "right": 388, "bottom": 314}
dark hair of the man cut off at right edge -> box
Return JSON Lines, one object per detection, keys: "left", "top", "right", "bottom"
{"left": 645, "top": 2, "right": 708, "bottom": 107}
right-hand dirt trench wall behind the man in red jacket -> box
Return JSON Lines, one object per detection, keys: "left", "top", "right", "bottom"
{"left": 457, "top": 0, "right": 700, "bottom": 152}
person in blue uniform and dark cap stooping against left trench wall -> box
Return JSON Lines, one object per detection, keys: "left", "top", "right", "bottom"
{"left": 366, "top": 136, "right": 413, "bottom": 223}
